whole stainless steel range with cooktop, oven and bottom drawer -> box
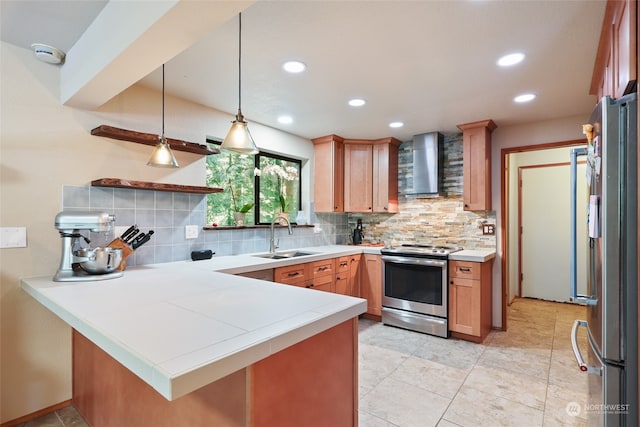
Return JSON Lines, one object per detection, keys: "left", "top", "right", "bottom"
{"left": 380, "top": 244, "right": 462, "bottom": 338}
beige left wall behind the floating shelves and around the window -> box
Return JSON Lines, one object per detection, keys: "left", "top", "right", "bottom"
{"left": 0, "top": 43, "right": 313, "bottom": 422}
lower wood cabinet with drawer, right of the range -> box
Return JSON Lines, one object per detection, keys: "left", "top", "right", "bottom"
{"left": 449, "top": 259, "right": 493, "bottom": 342}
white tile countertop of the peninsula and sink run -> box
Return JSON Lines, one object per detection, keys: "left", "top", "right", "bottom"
{"left": 21, "top": 246, "right": 367, "bottom": 400}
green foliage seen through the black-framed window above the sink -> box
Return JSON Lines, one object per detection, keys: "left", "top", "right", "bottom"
{"left": 207, "top": 146, "right": 301, "bottom": 226}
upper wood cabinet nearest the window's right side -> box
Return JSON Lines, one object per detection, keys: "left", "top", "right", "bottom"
{"left": 311, "top": 135, "right": 344, "bottom": 212}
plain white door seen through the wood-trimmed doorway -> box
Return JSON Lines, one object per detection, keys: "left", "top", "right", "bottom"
{"left": 520, "top": 164, "right": 588, "bottom": 302}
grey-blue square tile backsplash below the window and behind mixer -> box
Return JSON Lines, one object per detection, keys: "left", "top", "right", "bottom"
{"left": 62, "top": 185, "right": 349, "bottom": 265}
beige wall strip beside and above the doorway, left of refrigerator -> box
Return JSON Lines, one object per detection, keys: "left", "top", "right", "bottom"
{"left": 492, "top": 113, "right": 595, "bottom": 327}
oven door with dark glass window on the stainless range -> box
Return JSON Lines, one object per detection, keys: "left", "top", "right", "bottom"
{"left": 382, "top": 256, "right": 448, "bottom": 318}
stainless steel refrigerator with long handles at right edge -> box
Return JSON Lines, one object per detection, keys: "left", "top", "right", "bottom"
{"left": 571, "top": 93, "right": 638, "bottom": 427}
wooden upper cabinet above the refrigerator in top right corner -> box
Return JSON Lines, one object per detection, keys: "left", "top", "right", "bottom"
{"left": 590, "top": 0, "right": 638, "bottom": 99}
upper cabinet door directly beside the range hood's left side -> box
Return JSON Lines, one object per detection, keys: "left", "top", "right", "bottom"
{"left": 373, "top": 144, "right": 398, "bottom": 213}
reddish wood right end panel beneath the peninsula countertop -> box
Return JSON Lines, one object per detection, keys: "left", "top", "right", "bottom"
{"left": 251, "top": 319, "right": 358, "bottom": 427}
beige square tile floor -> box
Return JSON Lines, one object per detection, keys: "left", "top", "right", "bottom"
{"left": 15, "top": 299, "right": 587, "bottom": 427}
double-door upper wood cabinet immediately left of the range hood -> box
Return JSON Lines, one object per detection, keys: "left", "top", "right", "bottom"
{"left": 344, "top": 138, "right": 402, "bottom": 213}
